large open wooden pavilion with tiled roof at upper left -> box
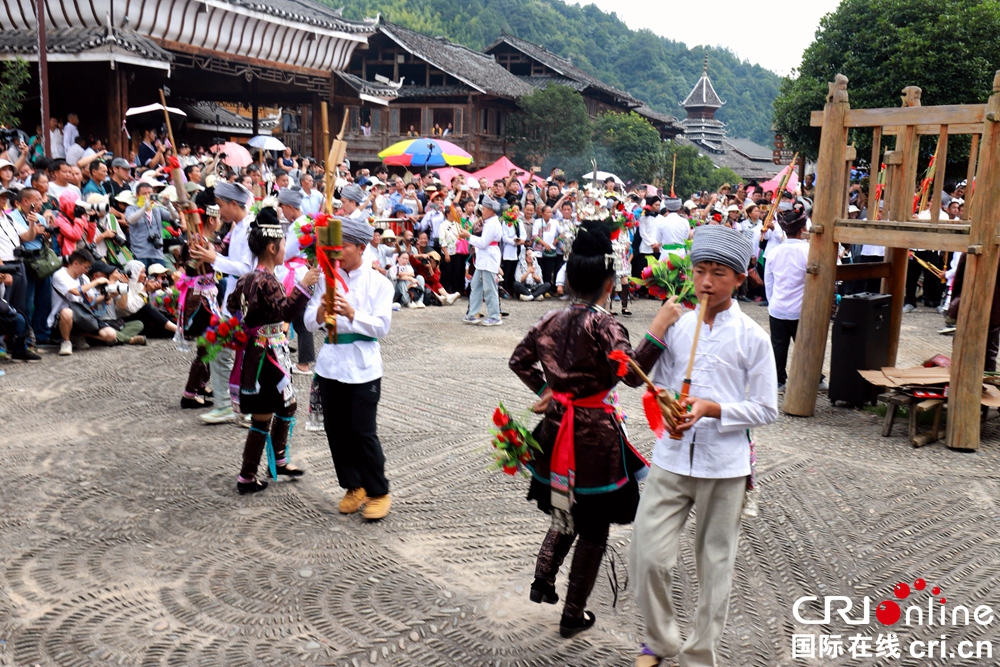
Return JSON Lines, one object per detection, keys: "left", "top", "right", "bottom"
{"left": 0, "top": 0, "right": 376, "bottom": 155}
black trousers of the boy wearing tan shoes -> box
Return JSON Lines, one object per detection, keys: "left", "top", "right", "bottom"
{"left": 319, "top": 377, "right": 389, "bottom": 496}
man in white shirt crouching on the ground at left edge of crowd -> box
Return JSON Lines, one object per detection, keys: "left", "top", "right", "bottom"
{"left": 48, "top": 249, "right": 118, "bottom": 357}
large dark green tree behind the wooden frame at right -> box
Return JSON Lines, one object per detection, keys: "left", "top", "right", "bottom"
{"left": 774, "top": 0, "right": 1000, "bottom": 164}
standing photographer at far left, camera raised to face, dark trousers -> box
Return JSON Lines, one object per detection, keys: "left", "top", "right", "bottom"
{"left": 10, "top": 188, "right": 59, "bottom": 345}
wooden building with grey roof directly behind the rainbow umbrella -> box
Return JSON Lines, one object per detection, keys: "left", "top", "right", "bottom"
{"left": 334, "top": 19, "right": 533, "bottom": 166}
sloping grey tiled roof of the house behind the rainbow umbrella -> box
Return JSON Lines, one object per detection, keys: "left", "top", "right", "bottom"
{"left": 378, "top": 20, "right": 534, "bottom": 99}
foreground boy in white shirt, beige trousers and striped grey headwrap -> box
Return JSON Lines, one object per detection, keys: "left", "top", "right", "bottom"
{"left": 630, "top": 225, "right": 778, "bottom": 667}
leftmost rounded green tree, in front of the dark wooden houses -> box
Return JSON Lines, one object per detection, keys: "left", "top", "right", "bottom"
{"left": 510, "top": 83, "right": 592, "bottom": 169}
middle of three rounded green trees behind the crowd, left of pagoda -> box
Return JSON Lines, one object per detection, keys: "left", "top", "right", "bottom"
{"left": 594, "top": 111, "right": 662, "bottom": 183}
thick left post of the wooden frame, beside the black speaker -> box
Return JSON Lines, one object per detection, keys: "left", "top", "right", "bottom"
{"left": 782, "top": 74, "right": 850, "bottom": 417}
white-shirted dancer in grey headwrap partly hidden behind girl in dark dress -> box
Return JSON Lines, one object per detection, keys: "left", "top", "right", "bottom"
{"left": 191, "top": 183, "right": 257, "bottom": 424}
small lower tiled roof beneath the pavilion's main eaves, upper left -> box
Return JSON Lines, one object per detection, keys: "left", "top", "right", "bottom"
{"left": 0, "top": 28, "right": 173, "bottom": 62}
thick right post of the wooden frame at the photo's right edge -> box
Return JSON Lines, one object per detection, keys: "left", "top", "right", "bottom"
{"left": 947, "top": 71, "right": 1000, "bottom": 450}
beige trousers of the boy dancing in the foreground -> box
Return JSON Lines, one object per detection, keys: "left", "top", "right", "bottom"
{"left": 629, "top": 464, "right": 746, "bottom": 667}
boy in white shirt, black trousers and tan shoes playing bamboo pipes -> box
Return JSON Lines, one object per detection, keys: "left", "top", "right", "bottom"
{"left": 304, "top": 218, "right": 393, "bottom": 521}
